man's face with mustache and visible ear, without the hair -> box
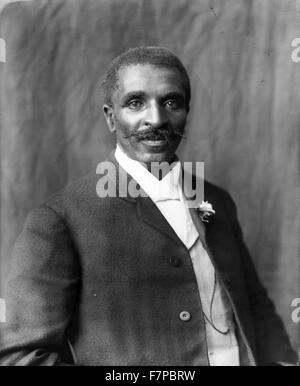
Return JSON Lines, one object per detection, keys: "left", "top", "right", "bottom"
{"left": 103, "top": 64, "right": 188, "bottom": 164}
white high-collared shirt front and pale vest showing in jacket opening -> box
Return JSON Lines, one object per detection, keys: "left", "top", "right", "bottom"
{"left": 115, "top": 145, "right": 239, "bottom": 366}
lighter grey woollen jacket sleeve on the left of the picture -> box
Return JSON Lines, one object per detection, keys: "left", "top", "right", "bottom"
{"left": 0, "top": 205, "right": 79, "bottom": 366}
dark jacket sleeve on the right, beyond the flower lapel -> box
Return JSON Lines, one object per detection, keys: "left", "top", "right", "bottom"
{"left": 226, "top": 192, "right": 297, "bottom": 365}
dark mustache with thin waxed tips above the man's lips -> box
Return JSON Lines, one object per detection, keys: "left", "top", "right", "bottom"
{"left": 124, "top": 126, "right": 186, "bottom": 141}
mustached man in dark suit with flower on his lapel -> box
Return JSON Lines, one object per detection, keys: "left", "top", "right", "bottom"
{"left": 0, "top": 47, "right": 296, "bottom": 366}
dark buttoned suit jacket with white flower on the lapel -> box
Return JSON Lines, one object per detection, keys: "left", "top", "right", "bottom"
{"left": 0, "top": 153, "right": 296, "bottom": 365}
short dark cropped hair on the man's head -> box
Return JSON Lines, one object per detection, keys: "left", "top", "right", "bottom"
{"left": 102, "top": 46, "right": 191, "bottom": 110}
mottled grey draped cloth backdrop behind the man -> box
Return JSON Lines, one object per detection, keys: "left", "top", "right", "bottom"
{"left": 0, "top": 0, "right": 300, "bottom": 349}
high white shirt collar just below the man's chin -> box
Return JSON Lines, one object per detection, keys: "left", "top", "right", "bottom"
{"left": 115, "top": 145, "right": 181, "bottom": 202}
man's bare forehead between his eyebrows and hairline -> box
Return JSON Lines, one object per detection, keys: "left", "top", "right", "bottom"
{"left": 117, "top": 64, "right": 185, "bottom": 94}
